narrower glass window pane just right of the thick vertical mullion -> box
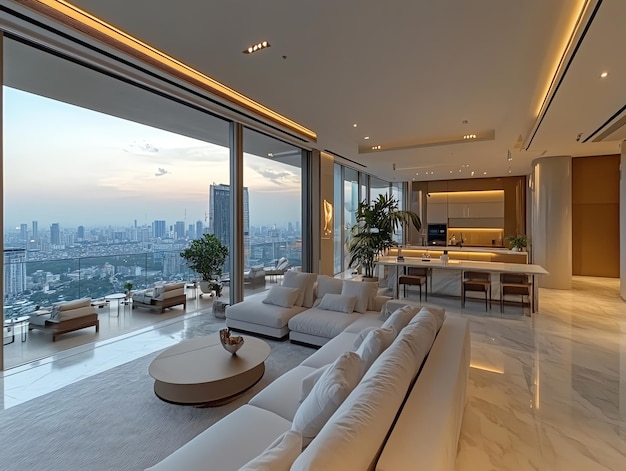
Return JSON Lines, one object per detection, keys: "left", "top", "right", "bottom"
{"left": 243, "top": 128, "right": 303, "bottom": 293}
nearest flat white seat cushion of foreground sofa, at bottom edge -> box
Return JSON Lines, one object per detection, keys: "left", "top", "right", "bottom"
{"left": 149, "top": 404, "right": 291, "bottom": 471}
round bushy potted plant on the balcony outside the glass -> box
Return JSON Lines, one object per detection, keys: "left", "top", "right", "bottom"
{"left": 180, "top": 234, "right": 228, "bottom": 297}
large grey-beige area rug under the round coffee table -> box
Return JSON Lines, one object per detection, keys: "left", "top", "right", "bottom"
{"left": 0, "top": 329, "right": 314, "bottom": 471}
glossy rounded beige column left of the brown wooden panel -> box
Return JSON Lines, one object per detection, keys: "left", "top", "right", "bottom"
{"left": 530, "top": 156, "right": 572, "bottom": 289}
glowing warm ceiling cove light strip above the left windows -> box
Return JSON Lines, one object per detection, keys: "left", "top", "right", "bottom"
{"left": 21, "top": 0, "right": 317, "bottom": 142}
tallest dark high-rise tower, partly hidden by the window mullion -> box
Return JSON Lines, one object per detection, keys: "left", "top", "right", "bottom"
{"left": 209, "top": 184, "right": 250, "bottom": 270}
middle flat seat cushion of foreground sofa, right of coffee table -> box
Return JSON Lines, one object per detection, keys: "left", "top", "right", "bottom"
{"left": 248, "top": 365, "right": 316, "bottom": 422}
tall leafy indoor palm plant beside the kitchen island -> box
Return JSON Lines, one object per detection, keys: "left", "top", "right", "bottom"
{"left": 348, "top": 194, "right": 422, "bottom": 279}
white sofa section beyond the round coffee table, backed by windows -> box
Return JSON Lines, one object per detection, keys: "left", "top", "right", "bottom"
{"left": 226, "top": 271, "right": 391, "bottom": 346}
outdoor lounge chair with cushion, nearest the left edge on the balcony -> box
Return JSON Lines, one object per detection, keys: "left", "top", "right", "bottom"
{"left": 29, "top": 298, "right": 100, "bottom": 342}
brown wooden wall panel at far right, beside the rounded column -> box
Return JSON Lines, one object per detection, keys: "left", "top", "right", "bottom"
{"left": 572, "top": 155, "right": 620, "bottom": 278}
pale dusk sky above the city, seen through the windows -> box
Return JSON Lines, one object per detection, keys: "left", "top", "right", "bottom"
{"left": 3, "top": 87, "right": 301, "bottom": 230}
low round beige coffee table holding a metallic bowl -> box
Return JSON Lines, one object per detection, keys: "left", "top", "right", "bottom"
{"left": 148, "top": 334, "right": 270, "bottom": 405}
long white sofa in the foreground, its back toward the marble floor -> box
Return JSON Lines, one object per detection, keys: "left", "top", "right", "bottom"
{"left": 150, "top": 307, "right": 470, "bottom": 471}
